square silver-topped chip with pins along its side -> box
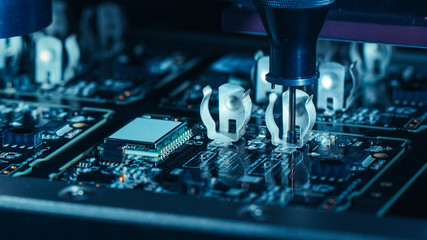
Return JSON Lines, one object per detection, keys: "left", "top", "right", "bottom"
{"left": 104, "top": 118, "right": 191, "bottom": 162}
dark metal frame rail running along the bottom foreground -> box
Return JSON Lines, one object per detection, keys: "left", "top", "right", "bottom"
{"left": 0, "top": 172, "right": 427, "bottom": 239}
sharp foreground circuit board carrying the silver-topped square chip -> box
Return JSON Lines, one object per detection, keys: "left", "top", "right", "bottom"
{"left": 55, "top": 115, "right": 409, "bottom": 215}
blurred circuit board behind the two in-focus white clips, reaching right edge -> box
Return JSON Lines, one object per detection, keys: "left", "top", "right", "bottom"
{"left": 159, "top": 54, "right": 427, "bottom": 132}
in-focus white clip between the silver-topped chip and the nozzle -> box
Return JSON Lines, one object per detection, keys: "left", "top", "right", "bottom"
{"left": 200, "top": 83, "right": 252, "bottom": 147}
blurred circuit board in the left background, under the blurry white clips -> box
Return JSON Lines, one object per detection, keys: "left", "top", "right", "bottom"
{"left": 0, "top": 45, "right": 203, "bottom": 104}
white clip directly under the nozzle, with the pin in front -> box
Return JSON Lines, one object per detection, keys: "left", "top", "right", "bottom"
{"left": 265, "top": 89, "right": 316, "bottom": 151}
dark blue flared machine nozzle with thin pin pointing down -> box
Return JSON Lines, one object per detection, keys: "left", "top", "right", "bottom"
{"left": 253, "top": 0, "right": 334, "bottom": 144}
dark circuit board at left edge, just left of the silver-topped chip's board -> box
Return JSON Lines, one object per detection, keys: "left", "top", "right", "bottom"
{"left": 0, "top": 100, "right": 112, "bottom": 176}
